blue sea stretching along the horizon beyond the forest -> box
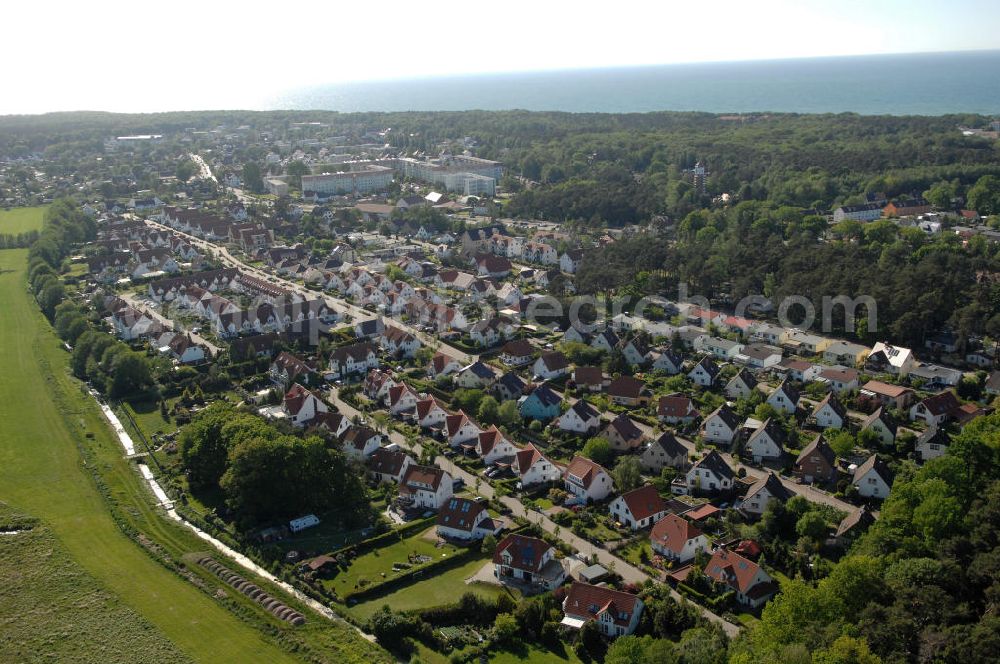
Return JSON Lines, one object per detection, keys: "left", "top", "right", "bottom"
{"left": 264, "top": 51, "right": 1000, "bottom": 115}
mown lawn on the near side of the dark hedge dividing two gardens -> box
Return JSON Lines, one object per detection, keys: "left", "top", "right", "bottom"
{"left": 348, "top": 557, "right": 508, "bottom": 620}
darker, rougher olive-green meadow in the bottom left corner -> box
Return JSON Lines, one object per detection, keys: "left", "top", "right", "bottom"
{"left": 0, "top": 503, "right": 191, "bottom": 664}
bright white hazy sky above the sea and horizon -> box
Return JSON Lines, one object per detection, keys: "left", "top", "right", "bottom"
{"left": 0, "top": 0, "right": 1000, "bottom": 113}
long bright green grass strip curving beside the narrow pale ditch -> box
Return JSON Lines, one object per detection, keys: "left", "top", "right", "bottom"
{"left": 0, "top": 250, "right": 388, "bottom": 662}
